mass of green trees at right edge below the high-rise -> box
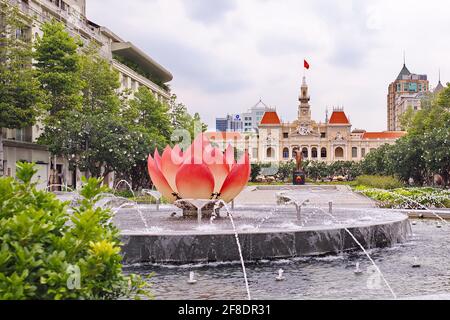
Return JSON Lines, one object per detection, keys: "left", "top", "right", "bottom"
{"left": 361, "top": 86, "right": 450, "bottom": 185}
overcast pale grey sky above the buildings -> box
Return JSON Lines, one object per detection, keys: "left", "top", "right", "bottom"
{"left": 87, "top": 0, "right": 450, "bottom": 130}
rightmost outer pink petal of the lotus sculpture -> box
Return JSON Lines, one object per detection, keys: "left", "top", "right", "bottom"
{"left": 220, "top": 152, "right": 251, "bottom": 202}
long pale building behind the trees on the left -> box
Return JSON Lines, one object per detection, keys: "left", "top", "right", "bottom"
{"left": 0, "top": 0, "right": 172, "bottom": 188}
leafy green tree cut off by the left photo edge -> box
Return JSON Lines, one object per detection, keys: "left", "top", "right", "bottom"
{"left": 0, "top": 1, "right": 43, "bottom": 176}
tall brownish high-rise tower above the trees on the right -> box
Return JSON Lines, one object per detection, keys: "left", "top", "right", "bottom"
{"left": 387, "top": 64, "right": 430, "bottom": 131}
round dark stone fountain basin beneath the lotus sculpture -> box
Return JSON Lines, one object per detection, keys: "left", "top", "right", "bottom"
{"left": 116, "top": 206, "right": 411, "bottom": 264}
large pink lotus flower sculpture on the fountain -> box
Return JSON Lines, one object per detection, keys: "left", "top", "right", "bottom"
{"left": 148, "top": 134, "right": 250, "bottom": 216}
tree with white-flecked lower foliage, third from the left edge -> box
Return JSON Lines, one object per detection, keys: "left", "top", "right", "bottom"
{"left": 40, "top": 42, "right": 128, "bottom": 177}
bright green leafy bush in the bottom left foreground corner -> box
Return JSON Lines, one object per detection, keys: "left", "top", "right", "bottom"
{"left": 0, "top": 163, "right": 148, "bottom": 300}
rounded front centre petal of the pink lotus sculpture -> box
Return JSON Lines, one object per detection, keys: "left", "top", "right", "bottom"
{"left": 175, "top": 163, "right": 214, "bottom": 199}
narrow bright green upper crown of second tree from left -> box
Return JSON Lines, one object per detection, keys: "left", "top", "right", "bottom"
{"left": 35, "top": 20, "right": 83, "bottom": 114}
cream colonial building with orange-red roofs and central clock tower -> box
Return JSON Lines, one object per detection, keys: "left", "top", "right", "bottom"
{"left": 208, "top": 78, "right": 406, "bottom": 163}
